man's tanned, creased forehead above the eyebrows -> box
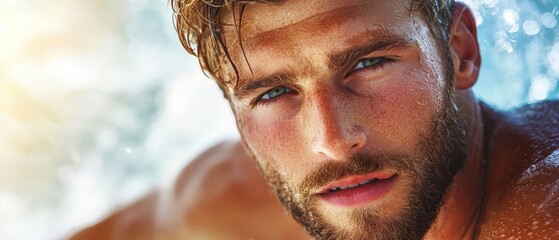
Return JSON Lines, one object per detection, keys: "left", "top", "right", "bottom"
{"left": 223, "top": 0, "right": 417, "bottom": 85}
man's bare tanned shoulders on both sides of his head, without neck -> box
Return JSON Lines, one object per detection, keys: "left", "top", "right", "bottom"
{"left": 71, "top": 101, "right": 559, "bottom": 240}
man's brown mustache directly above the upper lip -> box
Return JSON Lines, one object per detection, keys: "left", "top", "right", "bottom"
{"left": 299, "top": 153, "right": 417, "bottom": 195}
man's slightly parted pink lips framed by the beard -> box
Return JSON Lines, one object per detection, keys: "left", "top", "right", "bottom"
{"left": 316, "top": 172, "right": 398, "bottom": 207}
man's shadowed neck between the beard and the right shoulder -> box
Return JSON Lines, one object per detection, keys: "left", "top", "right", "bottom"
{"left": 425, "top": 93, "right": 486, "bottom": 239}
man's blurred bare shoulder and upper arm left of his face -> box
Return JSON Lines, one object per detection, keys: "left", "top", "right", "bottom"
{"left": 71, "top": 141, "right": 306, "bottom": 240}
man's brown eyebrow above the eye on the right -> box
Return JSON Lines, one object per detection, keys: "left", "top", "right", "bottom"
{"left": 328, "top": 35, "right": 412, "bottom": 70}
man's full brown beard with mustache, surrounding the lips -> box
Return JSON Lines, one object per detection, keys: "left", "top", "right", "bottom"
{"left": 247, "top": 86, "right": 467, "bottom": 240}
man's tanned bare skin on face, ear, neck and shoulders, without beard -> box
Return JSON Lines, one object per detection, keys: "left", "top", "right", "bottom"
{"left": 72, "top": 0, "right": 559, "bottom": 239}
